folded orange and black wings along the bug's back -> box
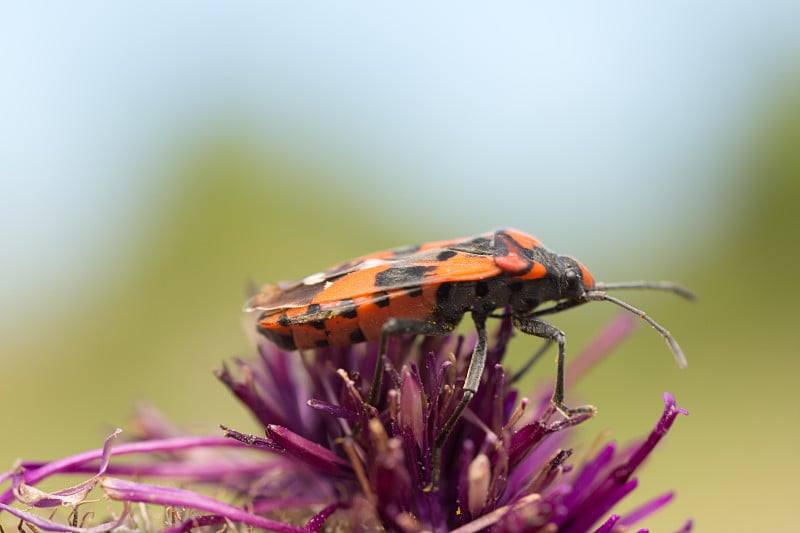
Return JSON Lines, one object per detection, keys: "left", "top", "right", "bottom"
{"left": 250, "top": 238, "right": 501, "bottom": 314}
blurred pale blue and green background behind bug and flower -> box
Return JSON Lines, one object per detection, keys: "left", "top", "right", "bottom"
{"left": 0, "top": 0, "right": 800, "bottom": 531}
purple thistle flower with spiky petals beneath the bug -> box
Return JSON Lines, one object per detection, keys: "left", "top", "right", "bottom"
{"left": 0, "top": 316, "right": 691, "bottom": 533}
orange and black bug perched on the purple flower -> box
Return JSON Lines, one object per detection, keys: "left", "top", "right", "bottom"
{"left": 245, "top": 229, "right": 692, "bottom": 454}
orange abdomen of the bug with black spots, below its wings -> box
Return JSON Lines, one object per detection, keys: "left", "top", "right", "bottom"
{"left": 258, "top": 287, "right": 437, "bottom": 350}
